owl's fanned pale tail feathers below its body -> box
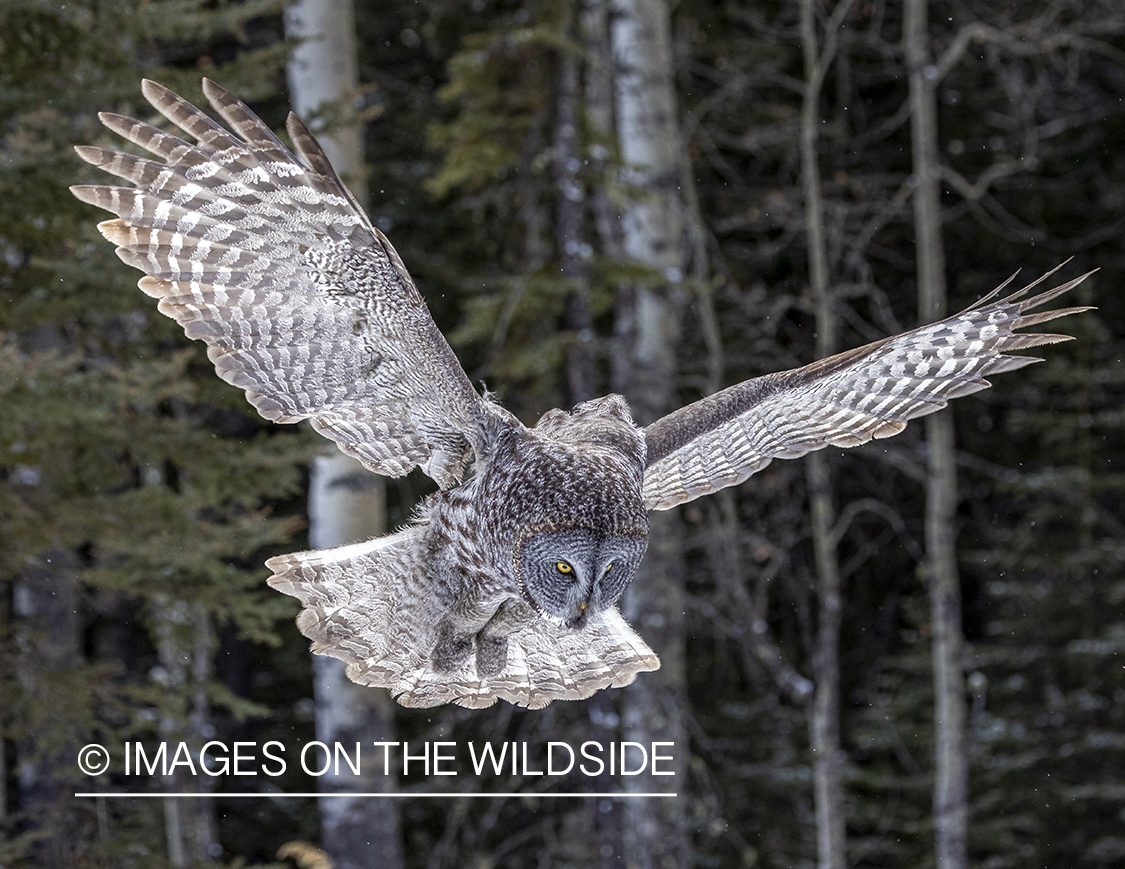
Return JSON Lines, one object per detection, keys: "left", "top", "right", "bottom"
{"left": 266, "top": 526, "right": 660, "bottom": 709}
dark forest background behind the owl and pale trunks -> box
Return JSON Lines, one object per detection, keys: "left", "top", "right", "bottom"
{"left": 0, "top": 0, "right": 1125, "bottom": 869}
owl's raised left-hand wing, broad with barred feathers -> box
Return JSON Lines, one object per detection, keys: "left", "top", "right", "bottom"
{"left": 71, "top": 79, "right": 486, "bottom": 487}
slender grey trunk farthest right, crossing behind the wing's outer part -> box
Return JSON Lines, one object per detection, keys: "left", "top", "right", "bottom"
{"left": 903, "top": 0, "right": 969, "bottom": 869}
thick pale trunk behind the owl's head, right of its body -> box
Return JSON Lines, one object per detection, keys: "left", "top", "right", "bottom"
{"left": 610, "top": 0, "right": 691, "bottom": 869}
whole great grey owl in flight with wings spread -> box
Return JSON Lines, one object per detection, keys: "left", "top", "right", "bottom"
{"left": 71, "top": 79, "right": 1087, "bottom": 708}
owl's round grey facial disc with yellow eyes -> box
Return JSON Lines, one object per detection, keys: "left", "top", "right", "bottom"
{"left": 515, "top": 527, "right": 648, "bottom": 630}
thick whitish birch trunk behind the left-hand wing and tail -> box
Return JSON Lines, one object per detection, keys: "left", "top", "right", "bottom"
{"left": 286, "top": 0, "right": 404, "bottom": 869}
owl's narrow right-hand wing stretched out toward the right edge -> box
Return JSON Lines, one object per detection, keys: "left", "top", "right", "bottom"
{"left": 644, "top": 267, "right": 1092, "bottom": 510}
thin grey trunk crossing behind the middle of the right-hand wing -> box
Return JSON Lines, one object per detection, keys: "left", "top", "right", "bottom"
{"left": 800, "top": 0, "right": 847, "bottom": 869}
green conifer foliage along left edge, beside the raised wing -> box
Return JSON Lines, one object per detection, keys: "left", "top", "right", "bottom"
{"left": 0, "top": 2, "right": 307, "bottom": 866}
